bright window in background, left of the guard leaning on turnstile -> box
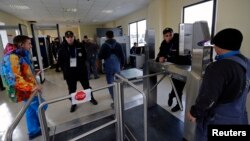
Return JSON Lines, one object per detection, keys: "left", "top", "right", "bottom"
{"left": 129, "top": 20, "right": 146, "bottom": 47}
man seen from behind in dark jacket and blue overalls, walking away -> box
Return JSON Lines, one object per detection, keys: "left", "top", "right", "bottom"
{"left": 98, "top": 31, "right": 125, "bottom": 107}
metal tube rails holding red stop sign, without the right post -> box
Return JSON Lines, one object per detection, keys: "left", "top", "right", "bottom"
{"left": 38, "top": 84, "right": 117, "bottom": 141}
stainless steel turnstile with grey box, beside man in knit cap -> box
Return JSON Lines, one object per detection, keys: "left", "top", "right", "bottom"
{"left": 143, "top": 21, "right": 212, "bottom": 141}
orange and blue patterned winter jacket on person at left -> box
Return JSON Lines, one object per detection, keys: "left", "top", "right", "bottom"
{"left": 0, "top": 43, "right": 36, "bottom": 102}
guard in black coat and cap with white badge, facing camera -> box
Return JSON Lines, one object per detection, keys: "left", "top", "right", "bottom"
{"left": 58, "top": 31, "right": 98, "bottom": 112}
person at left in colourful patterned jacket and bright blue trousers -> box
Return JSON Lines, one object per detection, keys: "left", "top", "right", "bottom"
{"left": 1, "top": 35, "right": 44, "bottom": 139}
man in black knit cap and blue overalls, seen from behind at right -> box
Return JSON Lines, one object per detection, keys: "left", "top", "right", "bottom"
{"left": 187, "top": 28, "right": 250, "bottom": 141}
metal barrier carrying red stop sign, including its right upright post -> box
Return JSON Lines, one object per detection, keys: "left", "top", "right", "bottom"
{"left": 38, "top": 82, "right": 123, "bottom": 141}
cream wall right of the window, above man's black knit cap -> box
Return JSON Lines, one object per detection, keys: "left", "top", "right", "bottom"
{"left": 216, "top": 0, "right": 250, "bottom": 58}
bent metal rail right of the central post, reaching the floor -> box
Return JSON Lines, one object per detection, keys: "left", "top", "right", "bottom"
{"left": 115, "top": 74, "right": 148, "bottom": 141}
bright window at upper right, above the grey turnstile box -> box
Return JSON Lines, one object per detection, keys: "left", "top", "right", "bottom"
{"left": 183, "top": 0, "right": 216, "bottom": 37}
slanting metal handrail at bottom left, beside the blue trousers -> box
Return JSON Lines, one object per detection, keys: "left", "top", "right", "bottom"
{"left": 4, "top": 90, "right": 40, "bottom": 141}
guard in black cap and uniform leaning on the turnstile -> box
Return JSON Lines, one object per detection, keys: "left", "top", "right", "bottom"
{"left": 156, "top": 27, "right": 191, "bottom": 112}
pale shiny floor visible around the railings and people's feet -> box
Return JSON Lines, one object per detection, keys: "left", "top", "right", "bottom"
{"left": 0, "top": 69, "right": 185, "bottom": 141}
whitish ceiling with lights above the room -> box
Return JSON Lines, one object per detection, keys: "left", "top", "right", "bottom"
{"left": 0, "top": 0, "right": 151, "bottom": 25}
